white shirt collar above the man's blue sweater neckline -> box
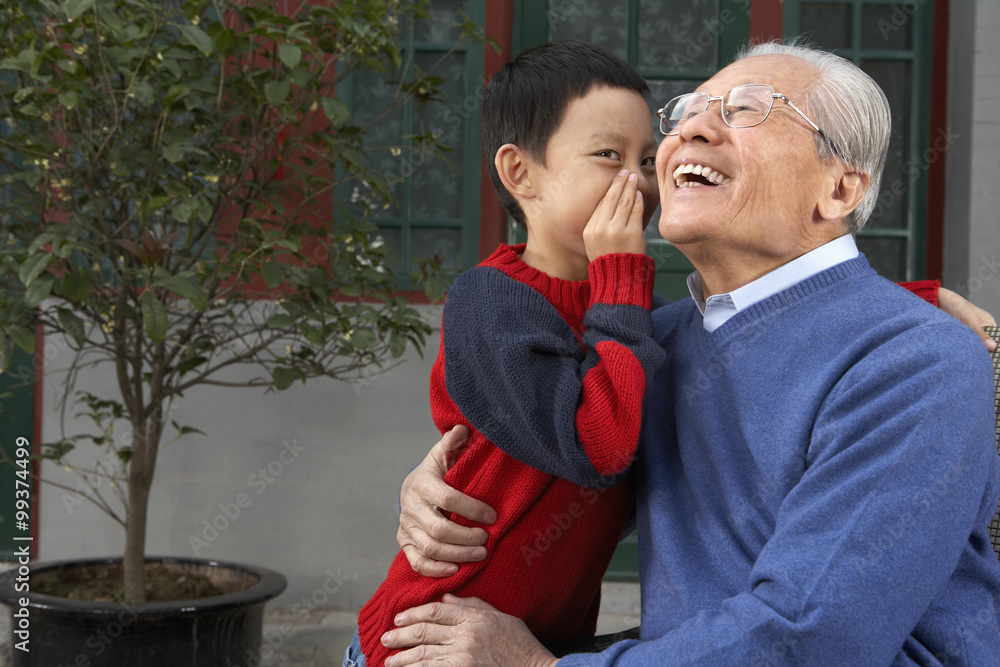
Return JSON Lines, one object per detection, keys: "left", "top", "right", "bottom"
{"left": 687, "top": 234, "right": 858, "bottom": 331}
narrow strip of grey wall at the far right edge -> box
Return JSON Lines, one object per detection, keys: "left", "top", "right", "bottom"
{"left": 944, "top": 0, "right": 1000, "bottom": 316}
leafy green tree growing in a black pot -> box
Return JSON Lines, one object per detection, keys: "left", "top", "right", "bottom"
{"left": 0, "top": 0, "right": 481, "bottom": 665}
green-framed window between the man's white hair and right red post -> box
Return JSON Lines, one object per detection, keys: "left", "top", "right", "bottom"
{"left": 784, "top": 0, "right": 932, "bottom": 281}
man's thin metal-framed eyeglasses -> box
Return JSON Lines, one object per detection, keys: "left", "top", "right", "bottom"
{"left": 656, "top": 83, "right": 836, "bottom": 144}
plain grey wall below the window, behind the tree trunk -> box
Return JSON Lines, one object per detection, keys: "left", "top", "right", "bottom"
{"left": 39, "top": 309, "right": 440, "bottom": 609}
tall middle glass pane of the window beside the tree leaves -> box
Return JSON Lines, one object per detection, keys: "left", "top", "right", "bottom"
{"left": 410, "top": 53, "right": 466, "bottom": 220}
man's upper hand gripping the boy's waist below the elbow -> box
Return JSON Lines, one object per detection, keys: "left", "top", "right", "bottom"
{"left": 396, "top": 426, "right": 497, "bottom": 578}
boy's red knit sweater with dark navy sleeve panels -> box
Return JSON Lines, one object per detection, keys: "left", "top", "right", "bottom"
{"left": 358, "top": 246, "right": 662, "bottom": 667}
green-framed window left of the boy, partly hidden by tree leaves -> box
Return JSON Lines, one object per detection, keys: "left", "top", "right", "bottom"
{"left": 335, "top": 0, "right": 486, "bottom": 289}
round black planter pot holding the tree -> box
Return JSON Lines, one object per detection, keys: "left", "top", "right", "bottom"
{"left": 0, "top": 558, "right": 288, "bottom": 667}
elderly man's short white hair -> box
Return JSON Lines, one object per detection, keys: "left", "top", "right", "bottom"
{"left": 736, "top": 42, "right": 892, "bottom": 234}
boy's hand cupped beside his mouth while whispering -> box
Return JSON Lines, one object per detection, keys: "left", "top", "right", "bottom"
{"left": 583, "top": 169, "right": 646, "bottom": 262}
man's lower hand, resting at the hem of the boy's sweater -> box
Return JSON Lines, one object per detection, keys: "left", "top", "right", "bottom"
{"left": 382, "top": 595, "right": 559, "bottom": 667}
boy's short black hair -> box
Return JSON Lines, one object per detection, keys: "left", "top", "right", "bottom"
{"left": 482, "top": 40, "right": 652, "bottom": 224}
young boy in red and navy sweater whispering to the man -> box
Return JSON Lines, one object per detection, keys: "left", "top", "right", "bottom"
{"left": 344, "top": 42, "right": 663, "bottom": 666}
